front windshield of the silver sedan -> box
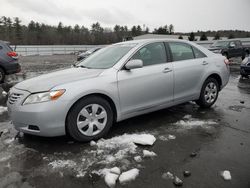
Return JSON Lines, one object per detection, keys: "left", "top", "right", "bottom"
{"left": 77, "top": 44, "right": 136, "bottom": 69}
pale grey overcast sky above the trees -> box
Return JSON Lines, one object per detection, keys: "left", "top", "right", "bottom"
{"left": 0, "top": 0, "right": 250, "bottom": 32}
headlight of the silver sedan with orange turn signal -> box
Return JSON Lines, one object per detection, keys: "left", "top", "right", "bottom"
{"left": 23, "top": 89, "right": 65, "bottom": 105}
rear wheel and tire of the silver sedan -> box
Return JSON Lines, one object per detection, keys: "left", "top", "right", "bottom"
{"left": 196, "top": 78, "right": 219, "bottom": 108}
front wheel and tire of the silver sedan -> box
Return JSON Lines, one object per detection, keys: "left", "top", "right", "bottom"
{"left": 66, "top": 96, "right": 114, "bottom": 142}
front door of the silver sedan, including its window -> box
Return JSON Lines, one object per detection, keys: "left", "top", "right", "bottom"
{"left": 118, "top": 42, "right": 173, "bottom": 114}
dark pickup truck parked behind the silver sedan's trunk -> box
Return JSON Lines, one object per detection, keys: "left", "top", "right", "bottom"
{"left": 209, "top": 40, "right": 249, "bottom": 60}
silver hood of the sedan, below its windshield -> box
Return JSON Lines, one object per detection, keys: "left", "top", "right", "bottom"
{"left": 14, "top": 67, "right": 104, "bottom": 93}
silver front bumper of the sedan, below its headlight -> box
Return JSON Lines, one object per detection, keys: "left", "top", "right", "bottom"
{"left": 7, "top": 88, "right": 68, "bottom": 137}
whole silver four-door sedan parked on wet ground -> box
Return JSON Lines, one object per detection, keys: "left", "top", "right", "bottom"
{"left": 7, "top": 39, "right": 229, "bottom": 141}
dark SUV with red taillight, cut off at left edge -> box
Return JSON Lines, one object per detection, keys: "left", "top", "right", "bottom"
{"left": 0, "top": 40, "right": 21, "bottom": 83}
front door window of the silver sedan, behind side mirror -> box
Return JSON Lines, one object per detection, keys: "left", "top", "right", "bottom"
{"left": 131, "top": 42, "right": 167, "bottom": 66}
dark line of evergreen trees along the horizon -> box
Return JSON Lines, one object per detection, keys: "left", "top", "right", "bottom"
{"left": 0, "top": 16, "right": 250, "bottom": 45}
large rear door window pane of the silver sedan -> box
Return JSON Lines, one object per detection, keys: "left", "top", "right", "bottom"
{"left": 169, "top": 42, "right": 195, "bottom": 61}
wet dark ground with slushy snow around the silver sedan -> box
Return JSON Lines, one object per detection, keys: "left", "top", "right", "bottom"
{"left": 0, "top": 55, "right": 250, "bottom": 188}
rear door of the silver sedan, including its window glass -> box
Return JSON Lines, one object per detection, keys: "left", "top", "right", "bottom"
{"left": 167, "top": 42, "right": 209, "bottom": 101}
